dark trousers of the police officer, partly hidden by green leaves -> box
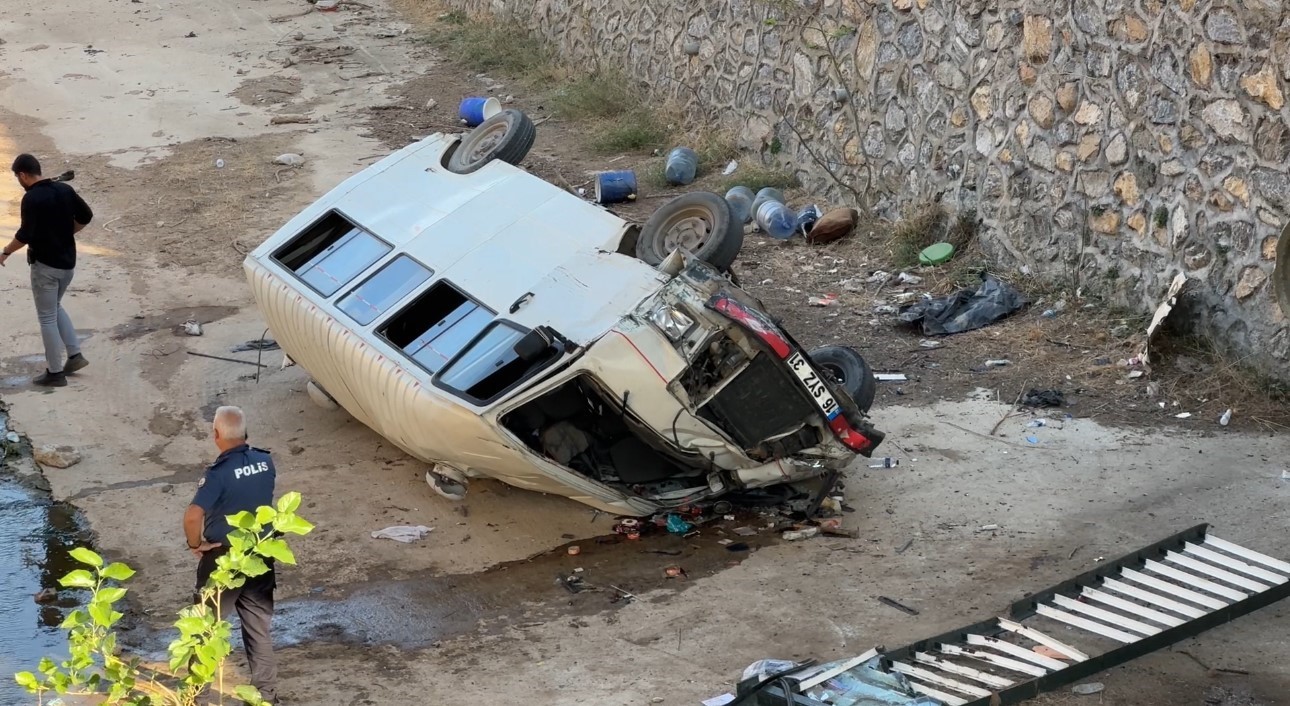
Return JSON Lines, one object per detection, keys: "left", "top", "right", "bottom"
{"left": 194, "top": 550, "right": 277, "bottom": 701}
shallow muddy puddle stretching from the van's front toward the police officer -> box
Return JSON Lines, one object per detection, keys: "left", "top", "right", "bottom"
{"left": 273, "top": 527, "right": 775, "bottom": 648}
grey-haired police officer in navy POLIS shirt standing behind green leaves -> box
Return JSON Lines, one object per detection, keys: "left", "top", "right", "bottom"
{"left": 183, "top": 407, "right": 277, "bottom": 703}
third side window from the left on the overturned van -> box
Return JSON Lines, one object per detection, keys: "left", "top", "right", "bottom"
{"left": 377, "top": 281, "right": 493, "bottom": 373}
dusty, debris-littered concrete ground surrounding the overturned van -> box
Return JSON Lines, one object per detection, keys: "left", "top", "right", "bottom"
{"left": 0, "top": 0, "right": 1290, "bottom": 706}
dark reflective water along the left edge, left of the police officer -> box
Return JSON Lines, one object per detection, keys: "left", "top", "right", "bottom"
{"left": 0, "top": 408, "right": 89, "bottom": 703}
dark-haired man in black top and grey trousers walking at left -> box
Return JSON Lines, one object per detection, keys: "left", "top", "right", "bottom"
{"left": 0, "top": 155, "right": 94, "bottom": 387}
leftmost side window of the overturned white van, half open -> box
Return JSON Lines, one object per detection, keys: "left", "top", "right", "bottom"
{"left": 273, "top": 212, "right": 391, "bottom": 297}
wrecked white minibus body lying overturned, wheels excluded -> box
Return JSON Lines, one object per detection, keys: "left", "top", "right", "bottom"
{"left": 244, "top": 134, "right": 881, "bottom": 515}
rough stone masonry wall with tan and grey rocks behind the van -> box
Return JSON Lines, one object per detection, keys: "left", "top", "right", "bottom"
{"left": 449, "top": 0, "right": 1290, "bottom": 377}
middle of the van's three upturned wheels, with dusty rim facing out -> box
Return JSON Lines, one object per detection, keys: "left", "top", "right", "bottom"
{"left": 636, "top": 191, "right": 743, "bottom": 271}
